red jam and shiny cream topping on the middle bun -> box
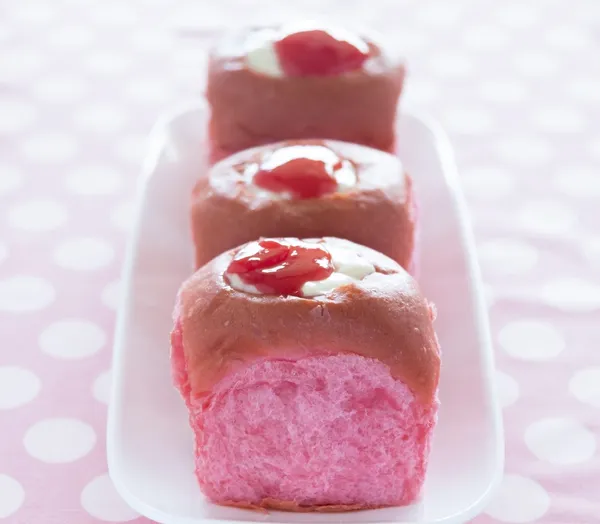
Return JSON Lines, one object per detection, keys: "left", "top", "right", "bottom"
{"left": 252, "top": 145, "right": 347, "bottom": 198}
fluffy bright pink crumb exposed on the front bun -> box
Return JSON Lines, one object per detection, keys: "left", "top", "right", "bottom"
{"left": 172, "top": 322, "right": 437, "bottom": 507}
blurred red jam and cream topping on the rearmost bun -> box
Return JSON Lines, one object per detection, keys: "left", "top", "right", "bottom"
{"left": 275, "top": 30, "right": 370, "bottom": 76}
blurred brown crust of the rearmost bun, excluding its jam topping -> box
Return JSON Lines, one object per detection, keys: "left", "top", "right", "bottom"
{"left": 206, "top": 29, "right": 405, "bottom": 157}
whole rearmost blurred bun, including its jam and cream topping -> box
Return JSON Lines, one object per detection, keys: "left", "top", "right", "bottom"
{"left": 206, "top": 23, "right": 405, "bottom": 160}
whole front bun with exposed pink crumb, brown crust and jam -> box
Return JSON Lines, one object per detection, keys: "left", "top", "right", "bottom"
{"left": 171, "top": 238, "right": 440, "bottom": 511}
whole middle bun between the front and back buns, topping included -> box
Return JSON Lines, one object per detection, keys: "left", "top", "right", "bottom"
{"left": 191, "top": 140, "right": 416, "bottom": 271}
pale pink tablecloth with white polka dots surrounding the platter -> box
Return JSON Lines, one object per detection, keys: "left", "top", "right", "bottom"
{"left": 0, "top": 0, "right": 600, "bottom": 524}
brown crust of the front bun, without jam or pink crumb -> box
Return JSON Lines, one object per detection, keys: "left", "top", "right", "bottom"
{"left": 172, "top": 239, "right": 440, "bottom": 405}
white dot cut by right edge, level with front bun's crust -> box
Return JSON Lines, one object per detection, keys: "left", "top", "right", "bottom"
{"left": 542, "top": 277, "right": 600, "bottom": 313}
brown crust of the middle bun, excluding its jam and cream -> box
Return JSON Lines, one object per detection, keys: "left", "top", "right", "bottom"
{"left": 191, "top": 140, "right": 416, "bottom": 270}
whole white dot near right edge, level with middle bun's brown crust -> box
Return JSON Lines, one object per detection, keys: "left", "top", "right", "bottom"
{"left": 517, "top": 200, "right": 577, "bottom": 236}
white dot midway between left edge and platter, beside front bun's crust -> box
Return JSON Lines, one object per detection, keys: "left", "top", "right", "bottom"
{"left": 39, "top": 319, "right": 106, "bottom": 360}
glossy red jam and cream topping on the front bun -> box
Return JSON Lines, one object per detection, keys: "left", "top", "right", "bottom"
{"left": 226, "top": 239, "right": 334, "bottom": 296}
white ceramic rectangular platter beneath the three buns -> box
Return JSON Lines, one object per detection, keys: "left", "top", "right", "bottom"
{"left": 108, "top": 106, "right": 504, "bottom": 524}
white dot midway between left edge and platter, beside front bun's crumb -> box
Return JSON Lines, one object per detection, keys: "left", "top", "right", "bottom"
{"left": 23, "top": 418, "right": 96, "bottom": 464}
